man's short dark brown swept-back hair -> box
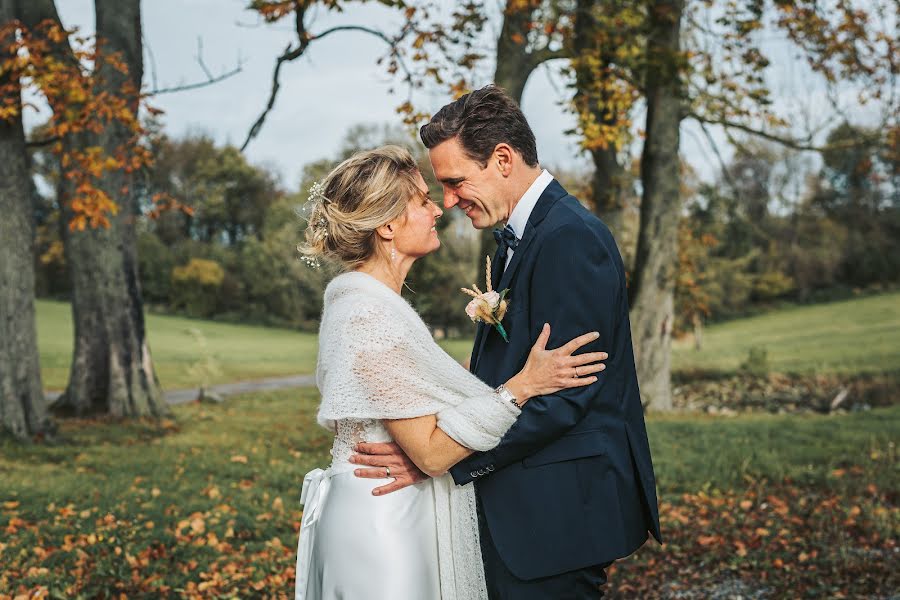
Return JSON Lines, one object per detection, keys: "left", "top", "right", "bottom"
{"left": 419, "top": 85, "right": 538, "bottom": 168}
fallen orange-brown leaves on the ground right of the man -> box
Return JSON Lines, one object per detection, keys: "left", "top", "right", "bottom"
{"left": 610, "top": 482, "right": 900, "bottom": 599}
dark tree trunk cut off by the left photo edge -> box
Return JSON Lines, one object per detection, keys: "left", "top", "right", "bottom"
{"left": 0, "top": 0, "right": 54, "bottom": 439}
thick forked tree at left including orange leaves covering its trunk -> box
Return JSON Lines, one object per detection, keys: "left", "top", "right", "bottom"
{"left": 22, "top": 0, "right": 167, "bottom": 416}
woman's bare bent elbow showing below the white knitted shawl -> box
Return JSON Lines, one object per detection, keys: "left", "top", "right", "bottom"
{"left": 384, "top": 415, "right": 473, "bottom": 477}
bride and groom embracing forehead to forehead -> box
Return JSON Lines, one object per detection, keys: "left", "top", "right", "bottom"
{"left": 296, "top": 86, "right": 660, "bottom": 600}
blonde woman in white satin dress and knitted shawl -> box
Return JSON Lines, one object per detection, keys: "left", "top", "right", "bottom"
{"left": 295, "top": 146, "right": 606, "bottom": 600}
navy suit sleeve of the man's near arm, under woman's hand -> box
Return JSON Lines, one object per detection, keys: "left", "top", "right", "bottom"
{"left": 450, "top": 223, "right": 622, "bottom": 485}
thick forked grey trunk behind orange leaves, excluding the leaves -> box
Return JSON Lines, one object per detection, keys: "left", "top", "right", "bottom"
{"left": 21, "top": 0, "right": 167, "bottom": 417}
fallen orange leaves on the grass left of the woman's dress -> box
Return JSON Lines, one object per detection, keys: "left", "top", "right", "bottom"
{"left": 0, "top": 490, "right": 300, "bottom": 600}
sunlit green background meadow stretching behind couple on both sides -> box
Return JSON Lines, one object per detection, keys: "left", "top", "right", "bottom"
{"left": 37, "top": 293, "right": 900, "bottom": 389}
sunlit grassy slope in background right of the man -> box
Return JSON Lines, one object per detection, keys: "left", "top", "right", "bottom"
{"left": 672, "top": 292, "right": 900, "bottom": 373}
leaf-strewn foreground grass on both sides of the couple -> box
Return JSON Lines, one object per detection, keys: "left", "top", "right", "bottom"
{"left": 0, "top": 389, "right": 900, "bottom": 598}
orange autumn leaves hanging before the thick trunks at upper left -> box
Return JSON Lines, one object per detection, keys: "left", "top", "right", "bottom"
{"left": 0, "top": 21, "right": 182, "bottom": 231}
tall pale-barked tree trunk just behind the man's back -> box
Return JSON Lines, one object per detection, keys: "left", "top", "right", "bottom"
{"left": 629, "top": 0, "right": 683, "bottom": 410}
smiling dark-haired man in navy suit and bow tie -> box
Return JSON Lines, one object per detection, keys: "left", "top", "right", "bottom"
{"left": 354, "top": 86, "right": 661, "bottom": 600}
